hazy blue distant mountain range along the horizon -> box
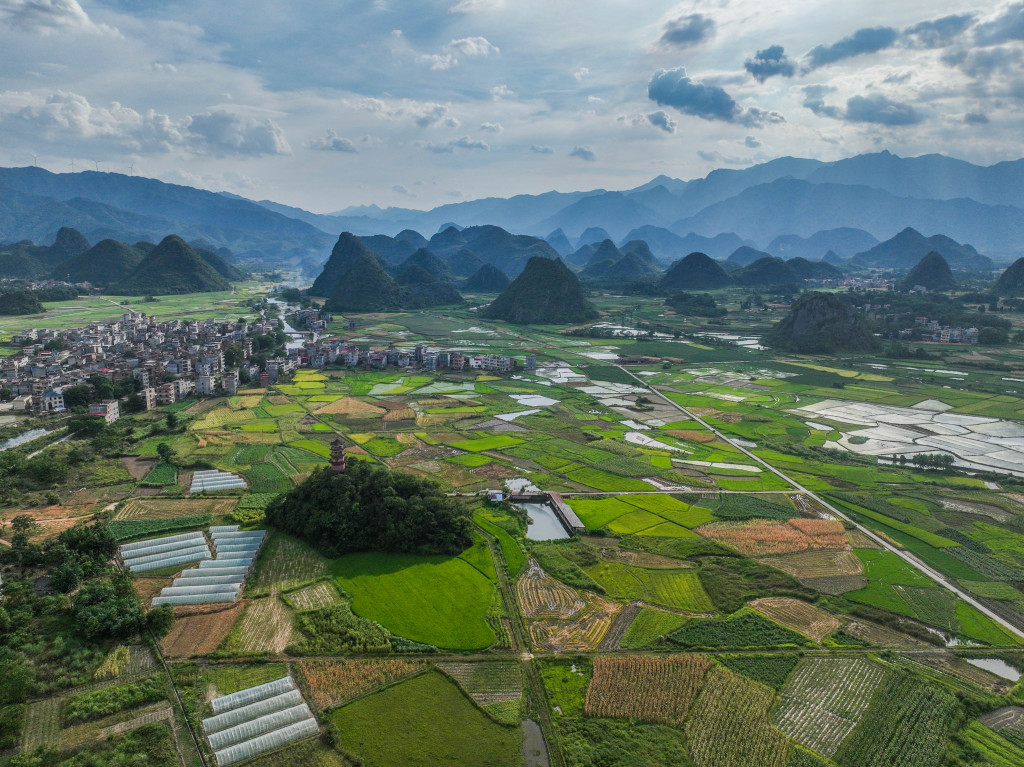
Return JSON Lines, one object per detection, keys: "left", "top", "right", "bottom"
{"left": 0, "top": 152, "right": 1024, "bottom": 276}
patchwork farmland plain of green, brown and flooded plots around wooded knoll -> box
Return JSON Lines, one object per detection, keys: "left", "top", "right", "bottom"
{"left": 22, "top": 290, "right": 1024, "bottom": 767}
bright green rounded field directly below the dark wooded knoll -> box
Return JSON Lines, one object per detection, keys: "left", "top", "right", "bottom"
{"left": 331, "top": 554, "right": 495, "bottom": 649}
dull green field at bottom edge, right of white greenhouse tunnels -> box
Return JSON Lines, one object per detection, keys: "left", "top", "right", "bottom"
{"left": 332, "top": 672, "right": 522, "bottom": 767}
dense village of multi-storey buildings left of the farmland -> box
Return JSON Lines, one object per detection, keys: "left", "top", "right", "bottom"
{"left": 6, "top": 312, "right": 537, "bottom": 423}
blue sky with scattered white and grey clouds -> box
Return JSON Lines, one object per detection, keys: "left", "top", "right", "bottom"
{"left": 0, "top": 0, "right": 1024, "bottom": 213}
